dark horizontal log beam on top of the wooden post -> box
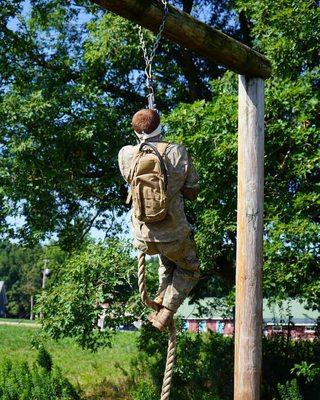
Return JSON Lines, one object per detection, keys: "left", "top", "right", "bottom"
{"left": 92, "top": 0, "right": 271, "bottom": 79}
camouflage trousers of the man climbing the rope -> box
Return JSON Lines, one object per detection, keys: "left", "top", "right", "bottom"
{"left": 134, "top": 236, "right": 200, "bottom": 312}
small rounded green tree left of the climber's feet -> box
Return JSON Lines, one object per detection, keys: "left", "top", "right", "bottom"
{"left": 37, "top": 239, "right": 141, "bottom": 350}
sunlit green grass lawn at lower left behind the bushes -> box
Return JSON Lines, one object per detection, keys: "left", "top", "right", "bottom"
{"left": 0, "top": 325, "right": 138, "bottom": 398}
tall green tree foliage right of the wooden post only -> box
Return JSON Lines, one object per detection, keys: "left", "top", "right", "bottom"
{"left": 239, "top": 0, "right": 320, "bottom": 309}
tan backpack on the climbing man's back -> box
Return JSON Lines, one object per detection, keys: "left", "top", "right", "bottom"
{"left": 129, "top": 142, "right": 169, "bottom": 223}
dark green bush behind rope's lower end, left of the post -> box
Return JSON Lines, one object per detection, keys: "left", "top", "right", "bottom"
{"left": 132, "top": 326, "right": 233, "bottom": 400}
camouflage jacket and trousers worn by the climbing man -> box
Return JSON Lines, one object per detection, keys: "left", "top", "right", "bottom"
{"left": 119, "top": 142, "right": 199, "bottom": 312}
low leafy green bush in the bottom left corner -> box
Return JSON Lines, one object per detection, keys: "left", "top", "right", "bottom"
{"left": 0, "top": 352, "right": 80, "bottom": 400}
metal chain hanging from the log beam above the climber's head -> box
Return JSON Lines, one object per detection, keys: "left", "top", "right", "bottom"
{"left": 138, "top": 0, "right": 169, "bottom": 109}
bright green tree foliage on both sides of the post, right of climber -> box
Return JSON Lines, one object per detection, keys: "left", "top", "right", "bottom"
{"left": 167, "top": 1, "right": 320, "bottom": 308}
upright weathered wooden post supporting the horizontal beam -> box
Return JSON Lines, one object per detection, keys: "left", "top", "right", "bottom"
{"left": 234, "top": 75, "right": 264, "bottom": 400}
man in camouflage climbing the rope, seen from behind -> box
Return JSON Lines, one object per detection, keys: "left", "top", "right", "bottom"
{"left": 118, "top": 109, "right": 200, "bottom": 330}
